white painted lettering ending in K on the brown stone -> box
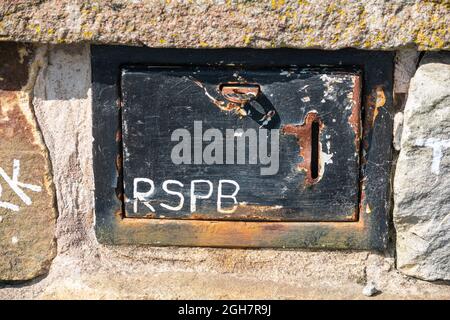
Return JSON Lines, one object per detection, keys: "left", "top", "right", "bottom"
{"left": 0, "top": 159, "right": 42, "bottom": 212}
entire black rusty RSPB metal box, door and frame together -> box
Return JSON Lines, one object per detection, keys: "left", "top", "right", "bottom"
{"left": 91, "top": 46, "right": 393, "bottom": 249}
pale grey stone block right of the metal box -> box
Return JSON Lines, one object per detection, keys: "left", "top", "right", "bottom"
{"left": 394, "top": 52, "right": 450, "bottom": 280}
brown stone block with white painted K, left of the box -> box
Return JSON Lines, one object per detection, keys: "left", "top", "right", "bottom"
{"left": 0, "top": 42, "right": 57, "bottom": 281}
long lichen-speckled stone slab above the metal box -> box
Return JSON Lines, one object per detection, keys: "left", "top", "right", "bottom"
{"left": 0, "top": 0, "right": 450, "bottom": 50}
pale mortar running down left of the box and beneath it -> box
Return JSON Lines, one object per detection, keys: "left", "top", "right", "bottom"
{"left": 0, "top": 45, "right": 450, "bottom": 299}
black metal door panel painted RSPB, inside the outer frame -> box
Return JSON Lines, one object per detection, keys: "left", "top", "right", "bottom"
{"left": 121, "top": 66, "right": 360, "bottom": 221}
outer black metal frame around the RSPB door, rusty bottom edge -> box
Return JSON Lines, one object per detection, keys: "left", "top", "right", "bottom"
{"left": 91, "top": 46, "right": 394, "bottom": 250}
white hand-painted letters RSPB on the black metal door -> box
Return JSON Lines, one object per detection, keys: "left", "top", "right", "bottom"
{"left": 133, "top": 178, "right": 240, "bottom": 213}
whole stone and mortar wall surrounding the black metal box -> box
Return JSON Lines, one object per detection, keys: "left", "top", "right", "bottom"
{"left": 0, "top": 1, "right": 450, "bottom": 299}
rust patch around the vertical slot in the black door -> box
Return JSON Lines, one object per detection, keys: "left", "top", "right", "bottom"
{"left": 281, "top": 111, "right": 324, "bottom": 186}
